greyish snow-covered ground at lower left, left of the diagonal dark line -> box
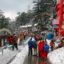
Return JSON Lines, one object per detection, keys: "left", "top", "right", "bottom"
{"left": 0, "top": 48, "right": 18, "bottom": 64}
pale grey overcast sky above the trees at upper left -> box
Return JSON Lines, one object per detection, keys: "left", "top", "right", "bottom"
{"left": 0, "top": 0, "right": 33, "bottom": 19}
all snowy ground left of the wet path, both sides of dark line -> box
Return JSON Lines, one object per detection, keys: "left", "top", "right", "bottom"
{"left": 0, "top": 38, "right": 29, "bottom": 64}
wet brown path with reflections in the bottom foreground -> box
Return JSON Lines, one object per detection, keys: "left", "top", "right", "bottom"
{"left": 24, "top": 56, "right": 51, "bottom": 64}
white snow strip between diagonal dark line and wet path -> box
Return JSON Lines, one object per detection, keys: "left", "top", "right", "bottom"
{"left": 10, "top": 38, "right": 30, "bottom": 64}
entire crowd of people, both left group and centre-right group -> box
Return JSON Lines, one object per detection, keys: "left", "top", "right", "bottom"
{"left": 0, "top": 32, "right": 64, "bottom": 61}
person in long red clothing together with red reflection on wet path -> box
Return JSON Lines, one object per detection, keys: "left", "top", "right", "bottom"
{"left": 38, "top": 39, "right": 48, "bottom": 64}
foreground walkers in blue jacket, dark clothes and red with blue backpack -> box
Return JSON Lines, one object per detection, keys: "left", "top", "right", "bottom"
{"left": 28, "top": 37, "right": 49, "bottom": 59}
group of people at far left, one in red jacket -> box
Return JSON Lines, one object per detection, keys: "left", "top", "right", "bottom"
{"left": 0, "top": 34, "right": 18, "bottom": 50}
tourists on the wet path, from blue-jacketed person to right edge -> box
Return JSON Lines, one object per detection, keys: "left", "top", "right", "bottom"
{"left": 28, "top": 31, "right": 64, "bottom": 61}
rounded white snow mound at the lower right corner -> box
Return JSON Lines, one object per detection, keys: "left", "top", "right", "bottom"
{"left": 48, "top": 47, "right": 64, "bottom": 64}
